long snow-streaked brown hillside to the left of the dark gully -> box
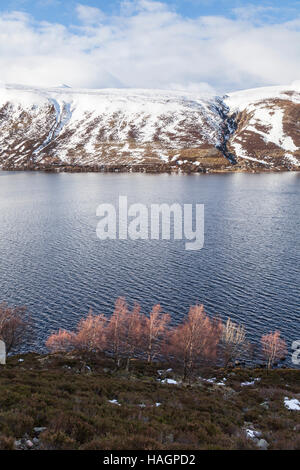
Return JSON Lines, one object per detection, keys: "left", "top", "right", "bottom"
{"left": 0, "top": 86, "right": 228, "bottom": 171}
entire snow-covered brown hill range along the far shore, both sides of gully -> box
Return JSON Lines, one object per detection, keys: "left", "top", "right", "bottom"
{"left": 0, "top": 84, "right": 300, "bottom": 171}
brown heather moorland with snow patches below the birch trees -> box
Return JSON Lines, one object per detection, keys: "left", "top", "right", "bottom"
{"left": 0, "top": 351, "right": 300, "bottom": 450}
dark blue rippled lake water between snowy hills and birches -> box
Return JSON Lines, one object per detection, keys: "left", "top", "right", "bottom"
{"left": 0, "top": 172, "right": 300, "bottom": 360}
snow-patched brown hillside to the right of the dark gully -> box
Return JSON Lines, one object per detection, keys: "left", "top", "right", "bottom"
{"left": 224, "top": 82, "right": 300, "bottom": 169}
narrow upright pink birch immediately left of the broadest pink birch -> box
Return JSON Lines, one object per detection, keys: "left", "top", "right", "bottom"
{"left": 143, "top": 304, "right": 171, "bottom": 363}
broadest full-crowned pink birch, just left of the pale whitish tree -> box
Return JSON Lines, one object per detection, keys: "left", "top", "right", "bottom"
{"left": 167, "top": 305, "right": 222, "bottom": 380}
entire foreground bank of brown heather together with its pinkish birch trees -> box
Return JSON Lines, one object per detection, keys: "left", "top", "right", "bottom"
{"left": 0, "top": 298, "right": 300, "bottom": 450}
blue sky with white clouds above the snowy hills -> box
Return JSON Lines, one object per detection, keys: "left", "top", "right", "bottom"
{"left": 0, "top": 0, "right": 300, "bottom": 93}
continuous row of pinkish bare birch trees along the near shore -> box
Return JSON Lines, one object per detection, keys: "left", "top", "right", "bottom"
{"left": 45, "top": 297, "right": 287, "bottom": 381}
